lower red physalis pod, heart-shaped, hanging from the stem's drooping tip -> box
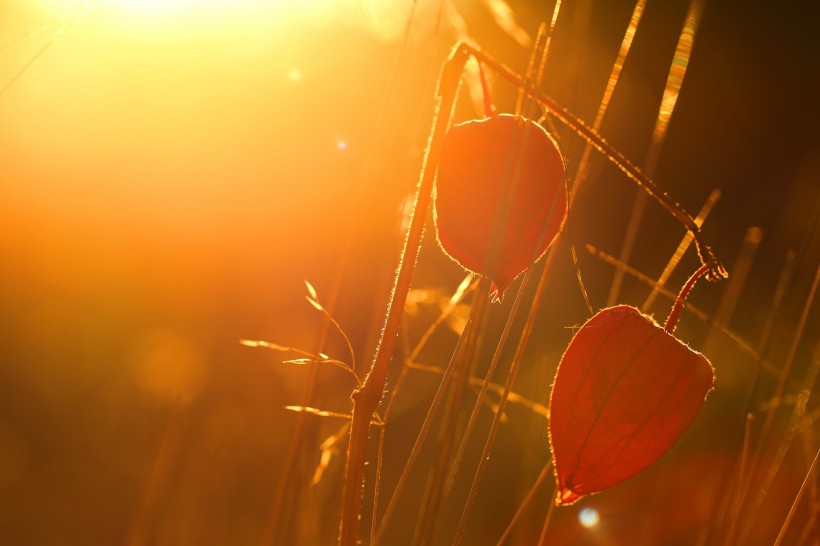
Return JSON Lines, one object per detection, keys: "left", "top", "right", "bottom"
{"left": 549, "top": 300, "right": 714, "bottom": 506}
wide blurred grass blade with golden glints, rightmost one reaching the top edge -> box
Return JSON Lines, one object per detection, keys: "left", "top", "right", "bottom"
{"left": 606, "top": 0, "right": 706, "bottom": 307}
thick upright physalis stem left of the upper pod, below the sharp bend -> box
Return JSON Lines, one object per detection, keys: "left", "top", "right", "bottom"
{"left": 339, "top": 43, "right": 468, "bottom": 546}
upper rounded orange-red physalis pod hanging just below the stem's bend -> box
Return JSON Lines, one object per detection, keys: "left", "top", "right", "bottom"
{"left": 435, "top": 114, "right": 567, "bottom": 299}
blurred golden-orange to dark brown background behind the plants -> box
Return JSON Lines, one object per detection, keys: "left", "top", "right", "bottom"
{"left": 0, "top": 0, "right": 820, "bottom": 546}
